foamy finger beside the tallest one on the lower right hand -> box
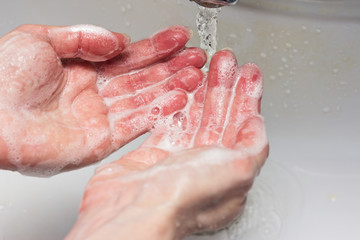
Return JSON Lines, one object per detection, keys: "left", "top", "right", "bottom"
{"left": 223, "top": 63, "right": 263, "bottom": 148}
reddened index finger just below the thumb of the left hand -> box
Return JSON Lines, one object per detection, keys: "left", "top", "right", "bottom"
{"left": 94, "top": 26, "right": 191, "bottom": 77}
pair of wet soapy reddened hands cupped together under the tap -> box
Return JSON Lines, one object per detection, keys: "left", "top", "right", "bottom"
{"left": 0, "top": 25, "right": 268, "bottom": 240}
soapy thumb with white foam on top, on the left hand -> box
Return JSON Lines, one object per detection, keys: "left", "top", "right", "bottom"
{"left": 38, "top": 25, "right": 130, "bottom": 62}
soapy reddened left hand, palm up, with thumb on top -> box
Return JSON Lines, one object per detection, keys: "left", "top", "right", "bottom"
{"left": 0, "top": 25, "right": 206, "bottom": 175}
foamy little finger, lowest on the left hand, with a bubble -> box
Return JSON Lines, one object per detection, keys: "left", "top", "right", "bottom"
{"left": 108, "top": 90, "right": 187, "bottom": 149}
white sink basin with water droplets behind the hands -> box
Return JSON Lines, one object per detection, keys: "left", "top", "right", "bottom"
{"left": 0, "top": 0, "right": 360, "bottom": 240}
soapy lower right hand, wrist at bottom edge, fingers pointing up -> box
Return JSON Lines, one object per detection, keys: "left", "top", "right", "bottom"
{"left": 67, "top": 50, "right": 268, "bottom": 240}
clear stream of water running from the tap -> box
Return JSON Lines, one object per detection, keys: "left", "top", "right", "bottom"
{"left": 196, "top": 6, "right": 221, "bottom": 66}
